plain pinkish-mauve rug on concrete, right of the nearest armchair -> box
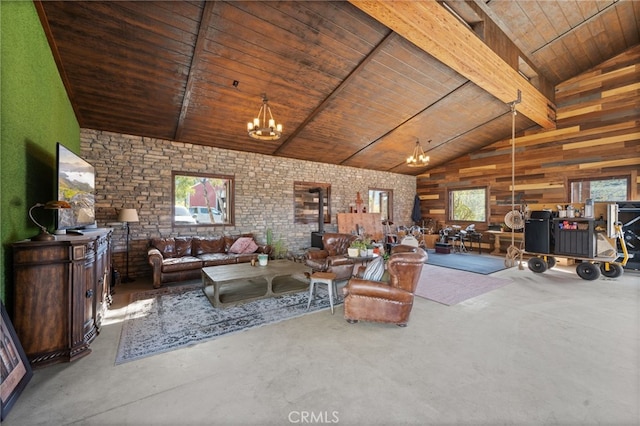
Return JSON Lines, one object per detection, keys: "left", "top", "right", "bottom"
{"left": 415, "top": 262, "right": 513, "bottom": 306}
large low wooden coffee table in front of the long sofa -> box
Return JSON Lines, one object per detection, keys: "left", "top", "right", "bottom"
{"left": 202, "top": 260, "right": 310, "bottom": 308}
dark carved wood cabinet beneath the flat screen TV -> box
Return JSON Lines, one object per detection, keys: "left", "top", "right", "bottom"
{"left": 13, "top": 229, "right": 112, "bottom": 368}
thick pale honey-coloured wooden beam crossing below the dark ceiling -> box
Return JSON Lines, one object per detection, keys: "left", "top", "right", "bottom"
{"left": 349, "top": 0, "right": 555, "bottom": 129}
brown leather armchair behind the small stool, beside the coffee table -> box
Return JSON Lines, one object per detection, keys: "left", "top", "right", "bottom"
{"left": 304, "top": 232, "right": 358, "bottom": 281}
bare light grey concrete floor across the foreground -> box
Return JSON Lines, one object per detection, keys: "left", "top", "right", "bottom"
{"left": 4, "top": 258, "right": 640, "bottom": 426}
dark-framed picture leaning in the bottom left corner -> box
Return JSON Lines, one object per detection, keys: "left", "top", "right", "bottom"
{"left": 0, "top": 301, "right": 33, "bottom": 421}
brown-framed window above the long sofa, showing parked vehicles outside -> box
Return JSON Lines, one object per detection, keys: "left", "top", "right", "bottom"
{"left": 171, "top": 172, "right": 234, "bottom": 226}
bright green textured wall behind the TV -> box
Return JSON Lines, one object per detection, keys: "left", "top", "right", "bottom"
{"left": 0, "top": 0, "right": 80, "bottom": 304}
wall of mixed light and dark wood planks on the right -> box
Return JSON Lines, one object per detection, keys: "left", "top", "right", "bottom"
{"left": 417, "top": 45, "right": 640, "bottom": 230}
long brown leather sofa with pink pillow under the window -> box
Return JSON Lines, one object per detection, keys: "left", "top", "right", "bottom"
{"left": 147, "top": 234, "right": 271, "bottom": 288}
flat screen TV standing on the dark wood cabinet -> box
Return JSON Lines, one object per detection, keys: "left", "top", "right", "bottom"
{"left": 56, "top": 142, "right": 96, "bottom": 230}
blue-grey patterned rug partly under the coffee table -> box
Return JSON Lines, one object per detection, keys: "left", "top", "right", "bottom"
{"left": 115, "top": 283, "right": 343, "bottom": 365}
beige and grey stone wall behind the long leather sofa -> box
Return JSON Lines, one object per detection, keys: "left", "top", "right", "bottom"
{"left": 81, "top": 129, "right": 416, "bottom": 277}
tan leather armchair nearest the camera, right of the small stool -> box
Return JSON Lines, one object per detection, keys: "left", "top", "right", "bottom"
{"left": 343, "top": 245, "right": 427, "bottom": 327}
